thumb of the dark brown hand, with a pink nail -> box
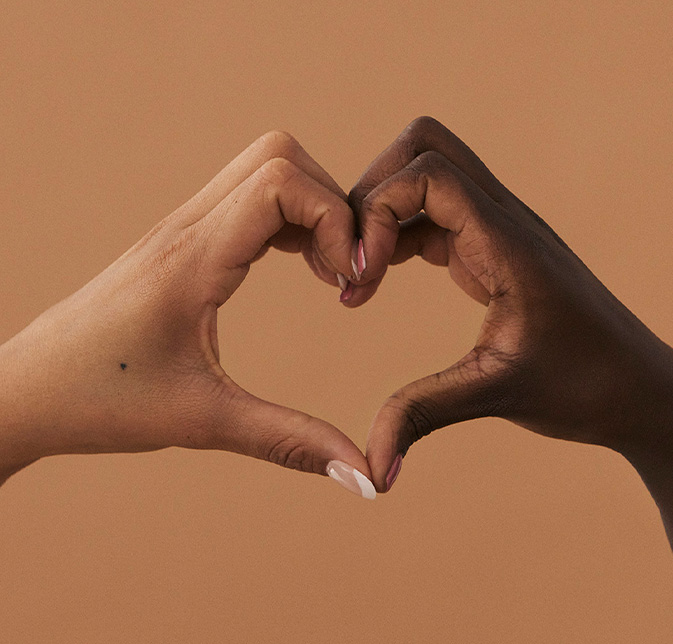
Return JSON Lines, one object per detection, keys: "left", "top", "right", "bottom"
{"left": 367, "top": 349, "right": 502, "bottom": 492}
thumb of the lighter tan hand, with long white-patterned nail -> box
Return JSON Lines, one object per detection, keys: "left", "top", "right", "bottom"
{"left": 207, "top": 383, "right": 376, "bottom": 499}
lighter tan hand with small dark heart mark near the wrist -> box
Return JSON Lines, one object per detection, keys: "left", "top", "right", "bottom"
{"left": 0, "top": 132, "right": 373, "bottom": 493}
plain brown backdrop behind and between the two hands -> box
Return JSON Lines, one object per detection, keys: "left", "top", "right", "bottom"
{"left": 0, "top": 0, "right": 673, "bottom": 644}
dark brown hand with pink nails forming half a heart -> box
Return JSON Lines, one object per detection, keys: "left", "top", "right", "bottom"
{"left": 346, "top": 117, "right": 673, "bottom": 543}
